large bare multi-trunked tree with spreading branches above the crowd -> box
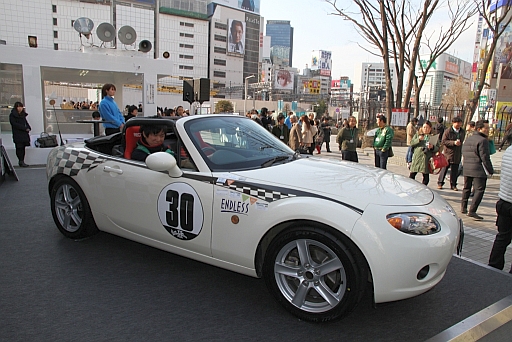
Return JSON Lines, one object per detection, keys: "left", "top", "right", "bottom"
{"left": 325, "top": 0, "right": 476, "bottom": 119}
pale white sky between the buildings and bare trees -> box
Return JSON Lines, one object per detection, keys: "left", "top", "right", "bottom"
{"left": 260, "top": 0, "right": 477, "bottom": 80}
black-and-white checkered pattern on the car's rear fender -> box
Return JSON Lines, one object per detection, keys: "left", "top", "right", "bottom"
{"left": 52, "top": 148, "right": 106, "bottom": 176}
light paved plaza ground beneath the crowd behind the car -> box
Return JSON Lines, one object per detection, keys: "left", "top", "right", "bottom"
{"left": 313, "top": 136, "right": 512, "bottom": 272}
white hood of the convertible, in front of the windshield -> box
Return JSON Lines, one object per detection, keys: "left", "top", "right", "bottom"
{"left": 232, "top": 158, "right": 434, "bottom": 210}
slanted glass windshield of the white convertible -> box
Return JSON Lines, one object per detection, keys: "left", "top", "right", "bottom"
{"left": 185, "top": 116, "right": 298, "bottom": 171}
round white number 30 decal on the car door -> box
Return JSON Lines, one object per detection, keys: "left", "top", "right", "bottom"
{"left": 158, "top": 183, "right": 203, "bottom": 240}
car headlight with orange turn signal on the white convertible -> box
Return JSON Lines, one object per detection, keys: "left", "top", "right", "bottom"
{"left": 386, "top": 213, "right": 441, "bottom": 235}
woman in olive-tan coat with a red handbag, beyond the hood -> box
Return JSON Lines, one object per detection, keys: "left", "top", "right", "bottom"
{"left": 409, "top": 120, "right": 439, "bottom": 185}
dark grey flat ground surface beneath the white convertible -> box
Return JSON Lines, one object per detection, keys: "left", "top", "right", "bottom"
{"left": 0, "top": 168, "right": 512, "bottom": 342}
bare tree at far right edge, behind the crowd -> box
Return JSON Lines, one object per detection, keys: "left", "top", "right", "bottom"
{"left": 465, "top": 0, "right": 512, "bottom": 124}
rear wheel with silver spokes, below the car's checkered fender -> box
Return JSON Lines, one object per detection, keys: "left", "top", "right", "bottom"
{"left": 50, "top": 178, "right": 98, "bottom": 239}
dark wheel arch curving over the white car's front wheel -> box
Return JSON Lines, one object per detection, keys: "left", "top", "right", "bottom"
{"left": 254, "top": 219, "right": 373, "bottom": 290}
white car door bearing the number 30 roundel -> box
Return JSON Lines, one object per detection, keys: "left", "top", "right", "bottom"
{"left": 95, "top": 158, "right": 213, "bottom": 255}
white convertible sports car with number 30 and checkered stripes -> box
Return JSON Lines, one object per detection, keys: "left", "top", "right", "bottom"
{"left": 47, "top": 115, "right": 463, "bottom": 321}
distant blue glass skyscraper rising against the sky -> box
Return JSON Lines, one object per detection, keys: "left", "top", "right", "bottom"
{"left": 266, "top": 20, "right": 293, "bottom": 67}
